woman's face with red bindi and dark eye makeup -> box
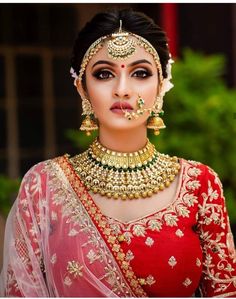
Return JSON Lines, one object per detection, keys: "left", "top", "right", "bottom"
{"left": 80, "top": 40, "right": 158, "bottom": 130}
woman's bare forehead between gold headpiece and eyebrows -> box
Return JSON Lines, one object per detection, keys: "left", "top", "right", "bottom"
{"left": 87, "top": 38, "right": 155, "bottom": 68}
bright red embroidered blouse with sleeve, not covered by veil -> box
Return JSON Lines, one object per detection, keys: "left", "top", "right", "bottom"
{"left": 101, "top": 160, "right": 236, "bottom": 297}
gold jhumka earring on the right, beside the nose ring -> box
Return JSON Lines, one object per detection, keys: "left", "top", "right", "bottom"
{"left": 147, "top": 97, "right": 166, "bottom": 135}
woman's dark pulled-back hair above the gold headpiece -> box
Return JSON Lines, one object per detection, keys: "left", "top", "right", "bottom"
{"left": 71, "top": 9, "right": 170, "bottom": 83}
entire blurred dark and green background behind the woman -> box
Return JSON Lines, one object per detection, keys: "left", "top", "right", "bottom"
{"left": 0, "top": 3, "right": 236, "bottom": 267}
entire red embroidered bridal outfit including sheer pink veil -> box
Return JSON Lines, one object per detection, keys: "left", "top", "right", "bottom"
{"left": 0, "top": 156, "right": 236, "bottom": 297}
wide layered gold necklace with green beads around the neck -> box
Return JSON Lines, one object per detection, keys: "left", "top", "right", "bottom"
{"left": 70, "top": 139, "right": 180, "bottom": 200}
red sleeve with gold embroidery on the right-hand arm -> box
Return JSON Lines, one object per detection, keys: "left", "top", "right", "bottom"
{"left": 198, "top": 167, "right": 236, "bottom": 297}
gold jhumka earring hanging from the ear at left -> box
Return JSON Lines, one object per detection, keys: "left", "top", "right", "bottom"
{"left": 80, "top": 98, "right": 98, "bottom": 136}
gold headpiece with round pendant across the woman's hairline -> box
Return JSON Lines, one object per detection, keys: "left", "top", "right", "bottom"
{"left": 76, "top": 20, "right": 163, "bottom": 87}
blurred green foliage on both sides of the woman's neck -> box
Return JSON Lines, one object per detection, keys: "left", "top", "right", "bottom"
{"left": 67, "top": 49, "right": 236, "bottom": 223}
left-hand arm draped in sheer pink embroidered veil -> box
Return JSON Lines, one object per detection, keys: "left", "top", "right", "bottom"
{"left": 1, "top": 164, "right": 48, "bottom": 297}
